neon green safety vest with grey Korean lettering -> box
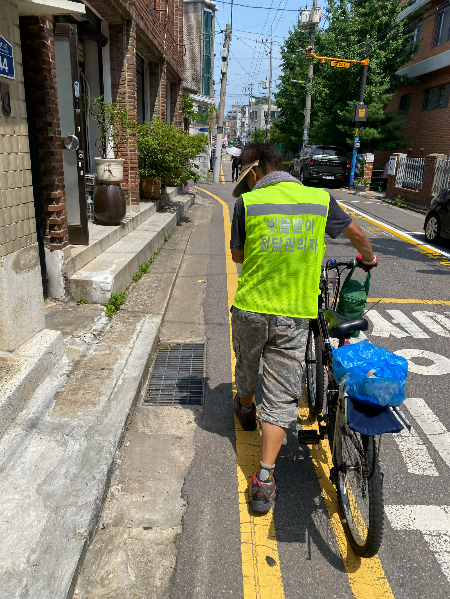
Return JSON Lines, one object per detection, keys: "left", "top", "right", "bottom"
{"left": 233, "top": 181, "right": 330, "bottom": 318}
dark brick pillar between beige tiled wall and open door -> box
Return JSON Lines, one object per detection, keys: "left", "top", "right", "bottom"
{"left": 20, "top": 17, "right": 69, "bottom": 250}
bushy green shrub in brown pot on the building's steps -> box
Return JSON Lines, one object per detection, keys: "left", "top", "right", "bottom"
{"left": 136, "top": 119, "right": 208, "bottom": 200}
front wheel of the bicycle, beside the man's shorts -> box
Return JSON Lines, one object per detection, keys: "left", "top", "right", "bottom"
{"left": 305, "top": 327, "right": 327, "bottom": 418}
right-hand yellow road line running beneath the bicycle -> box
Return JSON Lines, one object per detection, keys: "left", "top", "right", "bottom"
{"left": 298, "top": 404, "right": 394, "bottom": 599}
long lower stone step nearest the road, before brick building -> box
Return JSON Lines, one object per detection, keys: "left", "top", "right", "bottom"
{"left": 69, "top": 194, "right": 194, "bottom": 304}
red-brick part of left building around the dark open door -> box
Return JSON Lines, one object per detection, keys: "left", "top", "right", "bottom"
{"left": 7, "top": 0, "right": 183, "bottom": 297}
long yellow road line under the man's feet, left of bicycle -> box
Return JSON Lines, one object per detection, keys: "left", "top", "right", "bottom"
{"left": 196, "top": 188, "right": 284, "bottom": 599}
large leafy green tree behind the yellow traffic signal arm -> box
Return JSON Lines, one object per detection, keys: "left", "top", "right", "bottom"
{"left": 276, "top": 0, "right": 415, "bottom": 151}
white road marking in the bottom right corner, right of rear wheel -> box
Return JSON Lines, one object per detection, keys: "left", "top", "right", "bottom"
{"left": 384, "top": 505, "right": 450, "bottom": 582}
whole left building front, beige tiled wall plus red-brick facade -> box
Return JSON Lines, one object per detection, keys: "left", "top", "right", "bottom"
{"left": 0, "top": 0, "right": 183, "bottom": 370}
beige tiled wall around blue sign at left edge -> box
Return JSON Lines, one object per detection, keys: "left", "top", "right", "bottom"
{"left": 0, "top": 0, "right": 37, "bottom": 257}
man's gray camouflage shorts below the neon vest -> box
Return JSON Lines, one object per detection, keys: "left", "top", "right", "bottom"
{"left": 231, "top": 306, "right": 309, "bottom": 428}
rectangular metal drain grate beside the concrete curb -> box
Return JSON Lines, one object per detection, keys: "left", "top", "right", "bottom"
{"left": 145, "top": 343, "right": 205, "bottom": 406}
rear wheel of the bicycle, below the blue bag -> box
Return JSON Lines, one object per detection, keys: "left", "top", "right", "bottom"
{"left": 336, "top": 427, "right": 384, "bottom": 557}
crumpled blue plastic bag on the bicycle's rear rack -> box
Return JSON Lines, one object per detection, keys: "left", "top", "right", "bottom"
{"left": 333, "top": 339, "right": 408, "bottom": 407}
